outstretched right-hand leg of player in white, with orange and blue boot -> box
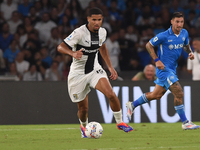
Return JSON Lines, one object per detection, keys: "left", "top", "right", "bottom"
{"left": 95, "top": 78, "right": 133, "bottom": 132}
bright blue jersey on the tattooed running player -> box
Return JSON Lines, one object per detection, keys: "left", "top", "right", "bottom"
{"left": 149, "top": 27, "right": 189, "bottom": 80}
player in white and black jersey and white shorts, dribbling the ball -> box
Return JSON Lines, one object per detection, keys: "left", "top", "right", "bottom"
{"left": 57, "top": 8, "right": 133, "bottom": 138}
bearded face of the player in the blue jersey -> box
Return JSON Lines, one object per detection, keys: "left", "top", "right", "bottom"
{"left": 171, "top": 17, "right": 184, "bottom": 34}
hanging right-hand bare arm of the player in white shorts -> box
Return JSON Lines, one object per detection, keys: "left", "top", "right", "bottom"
{"left": 99, "top": 43, "right": 118, "bottom": 80}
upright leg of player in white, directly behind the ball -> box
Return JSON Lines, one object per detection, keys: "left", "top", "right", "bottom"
{"left": 77, "top": 95, "right": 88, "bottom": 138}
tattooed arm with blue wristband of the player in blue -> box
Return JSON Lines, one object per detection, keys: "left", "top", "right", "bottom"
{"left": 146, "top": 42, "right": 165, "bottom": 70}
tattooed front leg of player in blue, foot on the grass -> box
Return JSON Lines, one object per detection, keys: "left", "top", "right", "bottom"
{"left": 169, "top": 81, "right": 199, "bottom": 130}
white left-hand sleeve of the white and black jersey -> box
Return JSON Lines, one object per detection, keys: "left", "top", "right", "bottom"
{"left": 64, "top": 30, "right": 81, "bottom": 48}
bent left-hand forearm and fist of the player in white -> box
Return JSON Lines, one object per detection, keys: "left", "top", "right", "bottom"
{"left": 57, "top": 42, "right": 83, "bottom": 60}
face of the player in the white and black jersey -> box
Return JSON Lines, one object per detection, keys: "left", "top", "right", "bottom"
{"left": 87, "top": 15, "right": 103, "bottom": 32}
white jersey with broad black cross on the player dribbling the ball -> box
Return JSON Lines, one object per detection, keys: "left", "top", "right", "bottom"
{"left": 64, "top": 25, "right": 107, "bottom": 74}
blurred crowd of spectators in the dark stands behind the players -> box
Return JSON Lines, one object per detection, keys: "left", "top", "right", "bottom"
{"left": 0, "top": 0, "right": 200, "bottom": 81}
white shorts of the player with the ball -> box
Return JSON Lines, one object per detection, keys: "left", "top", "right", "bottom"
{"left": 68, "top": 68, "right": 108, "bottom": 103}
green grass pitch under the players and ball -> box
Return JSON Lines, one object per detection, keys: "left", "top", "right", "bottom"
{"left": 0, "top": 122, "right": 200, "bottom": 150}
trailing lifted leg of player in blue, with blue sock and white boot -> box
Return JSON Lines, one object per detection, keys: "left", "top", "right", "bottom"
{"left": 126, "top": 84, "right": 166, "bottom": 121}
